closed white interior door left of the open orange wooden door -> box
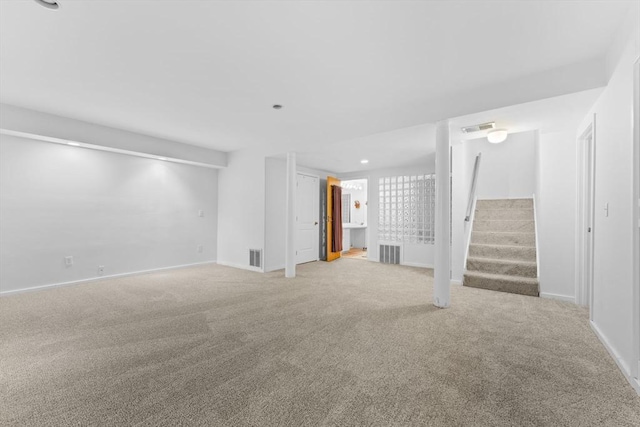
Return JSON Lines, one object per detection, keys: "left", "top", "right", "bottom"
{"left": 296, "top": 173, "right": 320, "bottom": 264}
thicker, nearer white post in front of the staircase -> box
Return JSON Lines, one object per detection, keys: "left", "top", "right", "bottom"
{"left": 433, "top": 121, "right": 451, "bottom": 308}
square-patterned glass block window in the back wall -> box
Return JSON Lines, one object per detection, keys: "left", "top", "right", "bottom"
{"left": 378, "top": 174, "right": 436, "bottom": 244}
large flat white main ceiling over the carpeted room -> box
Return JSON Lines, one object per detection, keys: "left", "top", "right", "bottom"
{"left": 0, "top": 0, "right": 633, "bottom": 164}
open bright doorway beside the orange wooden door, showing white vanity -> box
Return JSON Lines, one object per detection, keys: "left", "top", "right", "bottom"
{"left": 341, "top": 178, "right": 369, "bottom": 260}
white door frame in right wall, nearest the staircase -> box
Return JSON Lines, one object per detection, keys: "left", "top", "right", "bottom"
{"left": 575, "top": 114, "right": 596, "bottom": 320}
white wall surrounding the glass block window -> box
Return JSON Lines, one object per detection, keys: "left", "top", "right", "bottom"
{"left": 340, "top": 154, "right": 435, "bottom": 268}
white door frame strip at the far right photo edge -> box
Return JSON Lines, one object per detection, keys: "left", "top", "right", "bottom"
{"left": 631, "top": 57, "right": 640, "bottom": 384}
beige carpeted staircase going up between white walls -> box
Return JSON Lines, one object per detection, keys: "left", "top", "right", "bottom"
{"left": 463, "top": 199, "right": 539, "bottom": 297}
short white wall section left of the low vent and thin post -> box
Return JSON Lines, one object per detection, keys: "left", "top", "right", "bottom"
{"left": 218, "top": 150, "right": 264, "bottom": 271}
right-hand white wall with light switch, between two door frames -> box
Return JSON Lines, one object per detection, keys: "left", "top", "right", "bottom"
{"left": 578, "top": 12, "right": 640, "bottom": 388}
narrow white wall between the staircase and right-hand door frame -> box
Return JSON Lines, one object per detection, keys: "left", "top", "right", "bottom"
{"left": 536, "top": 132, "right": 577, "bottom": 301}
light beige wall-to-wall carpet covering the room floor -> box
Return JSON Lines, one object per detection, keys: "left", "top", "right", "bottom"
{"left": 0, "top": 259, "right": 640, "bottom": 426}
